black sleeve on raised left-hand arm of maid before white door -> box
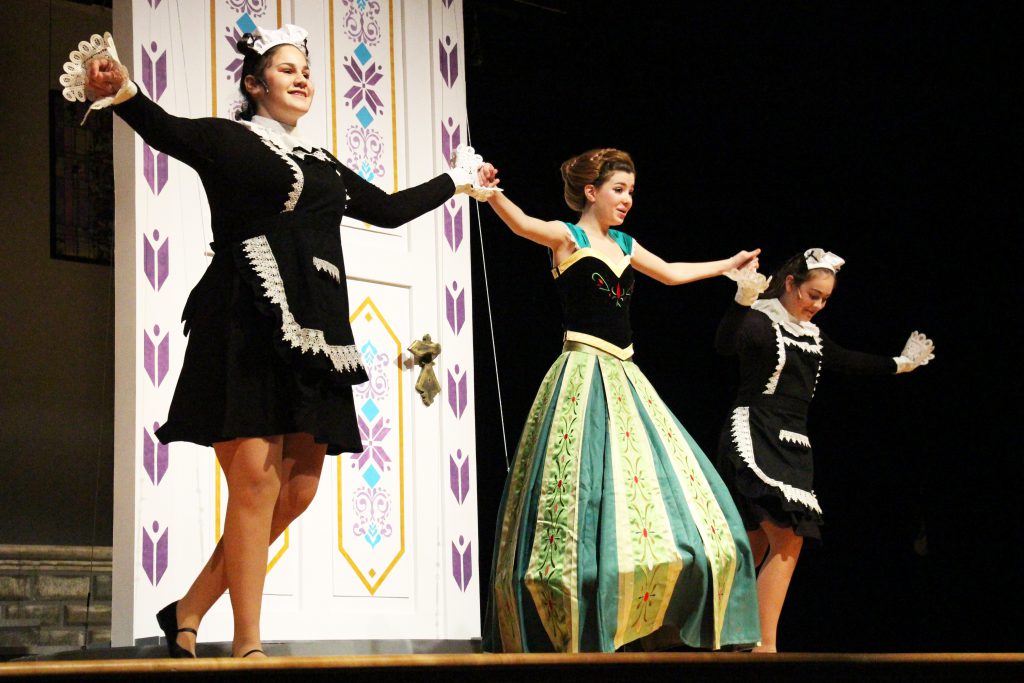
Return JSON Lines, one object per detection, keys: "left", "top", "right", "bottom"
{"left": 114, "top": 88, "right": 222, "bottom": 170}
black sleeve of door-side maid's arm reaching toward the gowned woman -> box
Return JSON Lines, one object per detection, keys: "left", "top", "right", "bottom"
{"left": 341, "top": 164, "right": 455, "bottom": 227}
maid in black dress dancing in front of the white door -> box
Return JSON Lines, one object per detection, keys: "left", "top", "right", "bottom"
{"left": 61, "top": 25, "right": 495, "bottom": 657}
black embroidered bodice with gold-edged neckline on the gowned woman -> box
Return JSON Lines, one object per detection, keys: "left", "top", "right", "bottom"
{"left": 553, "top": 226, "right": 634, "bottom": 349}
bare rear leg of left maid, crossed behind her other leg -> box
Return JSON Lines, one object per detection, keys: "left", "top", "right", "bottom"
{"left": 168, "top": 434, "right": 327, "bottom": 656}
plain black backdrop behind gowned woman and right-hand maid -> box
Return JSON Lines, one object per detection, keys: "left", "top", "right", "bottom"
{"left": 465, "top": 0, "right": 1024, "bottom": 651}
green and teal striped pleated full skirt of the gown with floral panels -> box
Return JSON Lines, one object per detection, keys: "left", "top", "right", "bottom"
{"left": 483, "top": 350, "right": 760, "bottom": 652}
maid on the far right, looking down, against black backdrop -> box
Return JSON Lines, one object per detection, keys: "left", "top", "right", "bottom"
{"left": 715, "top": 249, "right": 935, "bottom": 652}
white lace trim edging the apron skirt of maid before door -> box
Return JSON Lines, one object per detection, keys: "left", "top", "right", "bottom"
{"left": 242, "top": 234, "right": 362, "bottom": 373}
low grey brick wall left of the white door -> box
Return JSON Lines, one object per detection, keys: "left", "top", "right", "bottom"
{"left": 0, "top": 544, "right": 112, "bottom": 659}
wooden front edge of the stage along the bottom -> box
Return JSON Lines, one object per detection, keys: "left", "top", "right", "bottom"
{"left": 0, "top": 652, "right": 1024, "bottom": 683}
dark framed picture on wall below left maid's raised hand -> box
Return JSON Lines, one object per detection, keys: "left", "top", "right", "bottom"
{"left": 50, "top": 90, "right": 114, "bottom": 265}
